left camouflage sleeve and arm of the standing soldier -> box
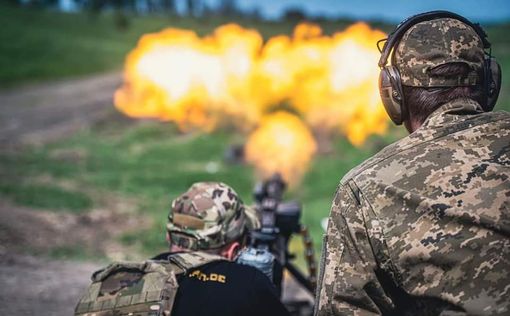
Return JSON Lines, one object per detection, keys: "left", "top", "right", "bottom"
{"left": 316, "top": 186, "right": 391, "bottom": 316}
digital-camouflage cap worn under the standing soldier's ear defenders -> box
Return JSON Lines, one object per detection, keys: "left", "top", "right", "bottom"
{"left": 392, "top": 18, "right": 485, "bottom": 87}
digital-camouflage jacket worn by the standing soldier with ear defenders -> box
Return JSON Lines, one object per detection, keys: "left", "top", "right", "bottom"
{"left": 316, "top": 99, "right": 510, "bottom": 316}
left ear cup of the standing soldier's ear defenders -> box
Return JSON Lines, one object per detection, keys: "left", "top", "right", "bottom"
{"left": 379, "top": 66, "right": 404, "bottom": 125}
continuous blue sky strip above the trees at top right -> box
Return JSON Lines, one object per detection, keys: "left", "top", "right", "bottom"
{"left": 233, "top": 0, "right": 510, "bottom": 22}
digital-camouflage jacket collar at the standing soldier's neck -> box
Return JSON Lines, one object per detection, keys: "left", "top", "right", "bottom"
{"left": 418, "top": 98, "right": 483, "bottom": 130}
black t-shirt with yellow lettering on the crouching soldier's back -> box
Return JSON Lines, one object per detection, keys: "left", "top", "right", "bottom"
{"left": 150, "top": 253, "right": 289, "bottom": 316}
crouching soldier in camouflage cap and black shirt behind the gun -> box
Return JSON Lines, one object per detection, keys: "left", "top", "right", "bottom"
{"left": 75, "top": 182, "right": 288, "bottom": 316}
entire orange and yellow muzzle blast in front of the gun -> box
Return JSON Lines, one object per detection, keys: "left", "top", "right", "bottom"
{"left": 115, "top": 23, "right": 387, "bottom": 183}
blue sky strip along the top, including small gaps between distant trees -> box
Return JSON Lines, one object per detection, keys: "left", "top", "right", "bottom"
{"left": 51, "top": 0, "right": 510, "bottom": 23}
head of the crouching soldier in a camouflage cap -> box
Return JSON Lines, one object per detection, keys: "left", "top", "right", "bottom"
{"left": 167, "top": 182, "right": 259, "bottom": 259}
